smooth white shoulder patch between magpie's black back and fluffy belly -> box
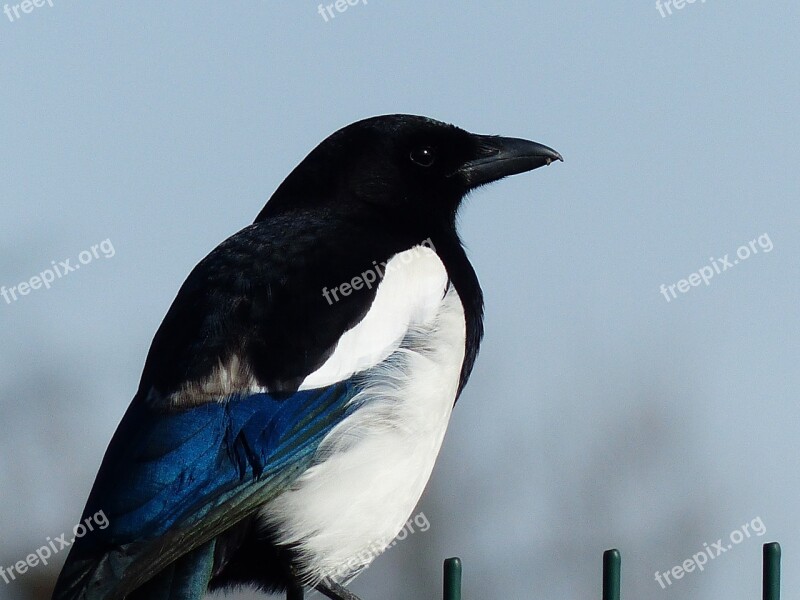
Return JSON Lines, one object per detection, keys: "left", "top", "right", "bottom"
{"left": 300, "top": 246, "right": 448, "bottom": 390}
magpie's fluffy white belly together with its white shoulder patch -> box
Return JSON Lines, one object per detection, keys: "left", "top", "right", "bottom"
{"left": 260, "top": 246, "right": 466, "bottom": 584}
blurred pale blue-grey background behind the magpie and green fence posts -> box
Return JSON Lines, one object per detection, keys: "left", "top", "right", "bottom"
{"left": 0, "top": 0, "right": 800, "bottom": 600}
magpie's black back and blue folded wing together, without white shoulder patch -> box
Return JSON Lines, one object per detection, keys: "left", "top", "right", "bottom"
{"left": 53, "top": 212, "right": 400, "bottom": 600}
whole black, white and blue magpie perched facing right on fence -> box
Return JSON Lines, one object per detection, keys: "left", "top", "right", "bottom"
{"left": 52, "top": 114, "right": 563, "bottom": 600}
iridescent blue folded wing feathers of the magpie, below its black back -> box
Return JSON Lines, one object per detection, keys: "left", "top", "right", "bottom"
{"left": 53, "top": 380, "right": 357, "bottom": 600}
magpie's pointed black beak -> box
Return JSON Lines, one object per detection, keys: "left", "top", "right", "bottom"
{"left": 458, "top": 135, "right": 564, "bottom": 188}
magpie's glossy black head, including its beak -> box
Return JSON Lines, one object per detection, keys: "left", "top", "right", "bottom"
{"left": 257, "top": 115, "right": 562, "bottom": 226}
